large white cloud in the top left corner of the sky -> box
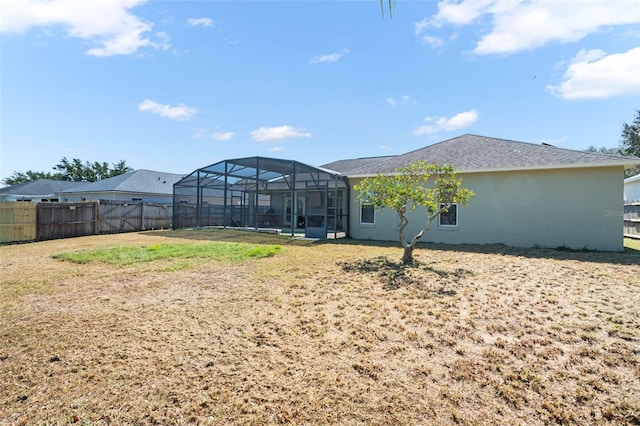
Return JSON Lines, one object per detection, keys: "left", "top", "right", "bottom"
{"left": 0, "top": 0, "right": 167, "bottom": 56}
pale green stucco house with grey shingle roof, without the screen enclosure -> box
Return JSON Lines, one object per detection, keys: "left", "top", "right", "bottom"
{"left": 324, "top": 135, "right": 640, "bottom": 251}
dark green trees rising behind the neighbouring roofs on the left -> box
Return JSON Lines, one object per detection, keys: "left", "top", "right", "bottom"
{"left": 2, "top": 157, "right": 133, "bottom": 186}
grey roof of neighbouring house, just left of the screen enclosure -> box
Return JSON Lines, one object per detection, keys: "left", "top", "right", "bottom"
{"left": 60, "top": 170, "right": 184, "bottom": 194}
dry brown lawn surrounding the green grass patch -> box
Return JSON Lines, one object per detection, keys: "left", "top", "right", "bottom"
{"left": 0, "top": 231, "right": 640, "bottom": 425}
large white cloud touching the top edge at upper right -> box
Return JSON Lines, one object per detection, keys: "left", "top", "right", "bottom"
{"left": 414, "top": 0, "right": 640, "bottom": 55}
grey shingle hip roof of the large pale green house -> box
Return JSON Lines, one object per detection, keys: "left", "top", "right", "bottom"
{"left": 336, "top": 134, "right": 640, "bottom": 176}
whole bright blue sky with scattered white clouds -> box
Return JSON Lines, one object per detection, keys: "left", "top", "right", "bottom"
{"left": 0, "top": 0, "right": 640, "bottom": 178}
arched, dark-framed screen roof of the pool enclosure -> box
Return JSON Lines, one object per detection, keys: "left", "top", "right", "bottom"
{"left": 175, "top": 157, "right": 345, "bottom": 190}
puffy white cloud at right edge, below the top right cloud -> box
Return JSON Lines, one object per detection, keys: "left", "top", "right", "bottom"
{"left": 547, "top": 47, "right": 640, "bottom": 99}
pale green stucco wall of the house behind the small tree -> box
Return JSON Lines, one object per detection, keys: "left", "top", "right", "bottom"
{"left": 350, "top": 167, "right": 623, "bottom": 251}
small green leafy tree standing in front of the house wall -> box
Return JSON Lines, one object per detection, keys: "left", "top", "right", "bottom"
{"left": 354, "top": 161, "right": 474, "bottom": 265}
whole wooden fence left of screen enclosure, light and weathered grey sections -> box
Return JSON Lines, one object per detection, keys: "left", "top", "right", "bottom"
{"left": 0, "top": 200, "right": 173, "bottom": 243}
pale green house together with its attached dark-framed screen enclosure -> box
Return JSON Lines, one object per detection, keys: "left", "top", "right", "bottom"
{"left": 173, "top": 134, "right": 640, "bottom": 251}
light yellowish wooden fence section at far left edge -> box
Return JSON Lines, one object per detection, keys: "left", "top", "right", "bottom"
{"left": 0, "top": 201, "right": 37, "bottom": 243}
